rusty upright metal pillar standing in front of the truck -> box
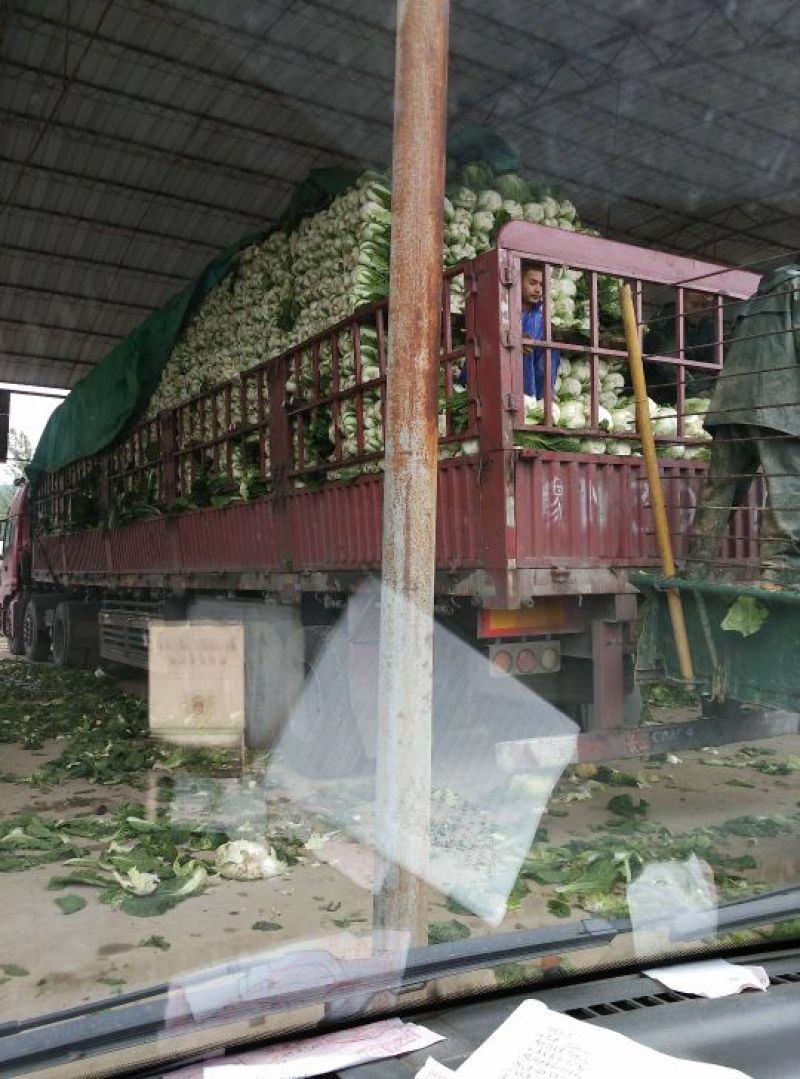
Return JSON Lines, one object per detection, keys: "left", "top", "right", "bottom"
{"left": 375, "top": 0, "right": 449, "bottom": 944}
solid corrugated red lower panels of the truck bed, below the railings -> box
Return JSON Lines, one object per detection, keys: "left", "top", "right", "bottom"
{"left": 33, "top": 450, "right": 757, "bottom": 606}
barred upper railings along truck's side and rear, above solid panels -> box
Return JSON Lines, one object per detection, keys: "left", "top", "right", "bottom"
{"left": 37, "top": 222, "right": 758, "bottom": 562}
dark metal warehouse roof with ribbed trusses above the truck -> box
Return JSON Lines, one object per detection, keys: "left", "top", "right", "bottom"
{"left": 0, "top": 0, "right": 800, "bottom": 387}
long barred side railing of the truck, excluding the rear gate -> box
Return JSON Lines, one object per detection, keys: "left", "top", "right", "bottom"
{"left": 38, "top": 264, "right": 477, "bottom": 531}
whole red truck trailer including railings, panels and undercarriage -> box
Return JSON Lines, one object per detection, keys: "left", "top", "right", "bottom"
{"left": 0, "top": 221, "right": 758, "bottom": 769}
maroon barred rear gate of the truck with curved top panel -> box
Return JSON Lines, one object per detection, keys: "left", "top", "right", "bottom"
{"left": 498, "top": 222, "right": 759, "bottom": 446}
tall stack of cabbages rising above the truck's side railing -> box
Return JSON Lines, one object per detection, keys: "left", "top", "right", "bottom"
{"left": 148, "top": 164, "right": 588, "bottom": 416}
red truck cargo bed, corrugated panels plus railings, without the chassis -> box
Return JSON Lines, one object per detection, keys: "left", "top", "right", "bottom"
{"left": 28, "top": 222, "right": 758, "bottom": 609}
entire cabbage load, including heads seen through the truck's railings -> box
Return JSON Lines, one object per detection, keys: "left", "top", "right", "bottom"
{"left": 142, "top": 164, "right": 647, "bottom": 489}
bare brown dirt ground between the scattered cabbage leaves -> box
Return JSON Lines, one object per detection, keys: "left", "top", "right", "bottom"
{"left": 0, "top": 651, "right": 800, "bottom": 1020}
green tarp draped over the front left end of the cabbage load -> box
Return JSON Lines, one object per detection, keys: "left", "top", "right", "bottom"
{"left": 26, "top": 234, "right": 265, "bottom": 483}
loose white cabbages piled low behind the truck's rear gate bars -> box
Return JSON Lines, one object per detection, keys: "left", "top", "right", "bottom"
{"left": 517, "top": 356, "right": 711, "bottom": 461}
